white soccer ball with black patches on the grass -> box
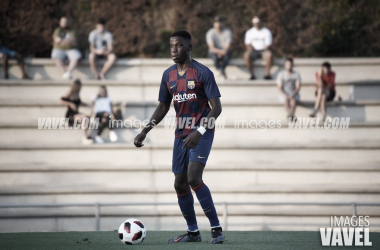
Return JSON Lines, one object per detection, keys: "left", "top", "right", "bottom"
{"left": 119, "top": 218, "right": 146, "bottom": 245}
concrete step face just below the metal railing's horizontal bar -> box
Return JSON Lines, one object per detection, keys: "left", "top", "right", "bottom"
{"left": 0, "top": 202, "right": 380, "bottom": 218}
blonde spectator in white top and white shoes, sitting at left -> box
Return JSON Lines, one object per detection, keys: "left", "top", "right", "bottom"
{"left": 91, "top": 86, "right": 117, "bottom": 143}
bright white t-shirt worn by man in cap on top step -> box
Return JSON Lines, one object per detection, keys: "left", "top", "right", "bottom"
{"left": 244, "top": 27, "right": 273, "bottom": 50}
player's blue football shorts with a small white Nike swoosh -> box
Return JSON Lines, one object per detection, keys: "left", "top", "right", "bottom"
{"left": 172, "top": 130, "right": 214, "bottom": 174}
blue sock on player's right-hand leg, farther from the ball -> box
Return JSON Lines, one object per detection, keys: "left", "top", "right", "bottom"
{"left": 193, "top": 181, "right": 220, "bottom": 227}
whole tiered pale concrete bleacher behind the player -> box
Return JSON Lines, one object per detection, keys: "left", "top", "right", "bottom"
{"left": 0, "top": 58, "right": 380, "bottom": 232}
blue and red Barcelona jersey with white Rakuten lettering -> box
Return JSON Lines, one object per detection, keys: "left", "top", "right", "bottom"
{"left": 158, "top": 59, "right": 220, "bottom": 137}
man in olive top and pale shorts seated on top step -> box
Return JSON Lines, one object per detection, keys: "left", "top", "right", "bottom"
{"left": 51, "top": 17, "right": 82, "bottom": 79}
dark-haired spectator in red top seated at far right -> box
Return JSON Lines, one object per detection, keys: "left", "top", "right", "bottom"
{"left": 310, "top": 62, "right": 336, "bottom": 121}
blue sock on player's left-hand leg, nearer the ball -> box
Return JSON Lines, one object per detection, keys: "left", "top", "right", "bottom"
{"left": 177, "top": 188, "right": 198, "bottom": 232}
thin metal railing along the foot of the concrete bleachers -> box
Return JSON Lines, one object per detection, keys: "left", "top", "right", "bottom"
{"left": 0, "top": 202, "right": 380, "bottom": 231}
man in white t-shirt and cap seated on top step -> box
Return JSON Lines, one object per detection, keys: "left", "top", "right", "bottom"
{"left": 244, "top": 16, "right": 273, "bottom": 80}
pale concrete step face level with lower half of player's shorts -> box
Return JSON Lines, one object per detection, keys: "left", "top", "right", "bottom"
{"left": 0, "top": 145, "right": 380, "bottom": 171}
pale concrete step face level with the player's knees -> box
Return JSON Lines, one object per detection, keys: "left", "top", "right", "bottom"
{"left": 0, "top": 168, "right": 380, "bottom": 188}
